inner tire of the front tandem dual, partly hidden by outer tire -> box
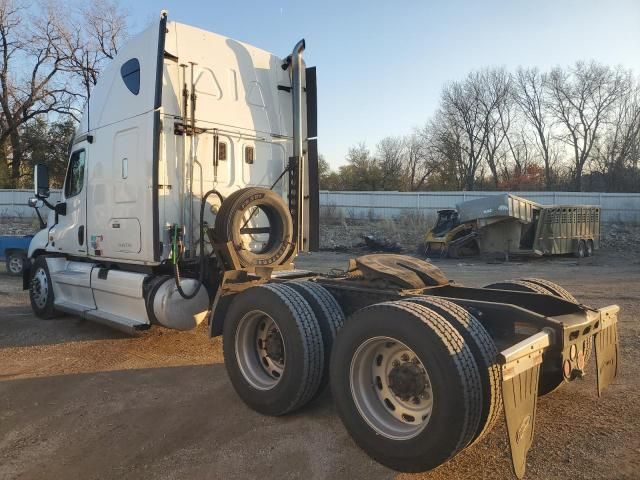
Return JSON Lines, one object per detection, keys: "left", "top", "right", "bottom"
{"left": 286, "top": 282, "right": 344, "bottom": 396}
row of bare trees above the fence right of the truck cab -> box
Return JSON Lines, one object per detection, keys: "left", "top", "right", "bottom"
{"left": 320, "top": 62, "right": 640, "bottom": 192}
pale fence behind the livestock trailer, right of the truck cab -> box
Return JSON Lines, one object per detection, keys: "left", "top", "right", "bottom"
{"left": 320, "top": 191, "right": 640, "bottom": 223}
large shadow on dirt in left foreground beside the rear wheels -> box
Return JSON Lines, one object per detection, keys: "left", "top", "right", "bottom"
{"left": 0, "top": 365, "right": 384, "bottom": 480}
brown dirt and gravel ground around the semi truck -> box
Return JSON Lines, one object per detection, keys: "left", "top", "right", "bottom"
{"left": 0, "top": 251, "right": 640, "bottom": 480}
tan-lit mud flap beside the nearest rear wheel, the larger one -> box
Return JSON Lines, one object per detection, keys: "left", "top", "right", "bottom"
{"left": 499, "top": 331, "right": 551, "bottom": 479}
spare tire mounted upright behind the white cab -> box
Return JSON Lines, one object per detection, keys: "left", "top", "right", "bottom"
{"left": 215, "top": 187, "right": 295, "bottom": 267}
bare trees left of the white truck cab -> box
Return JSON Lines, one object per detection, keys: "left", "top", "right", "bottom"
{"left": 0, "top": 0, "right": 128, "bottom": 188}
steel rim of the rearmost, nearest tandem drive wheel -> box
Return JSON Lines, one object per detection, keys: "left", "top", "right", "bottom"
{"left": 349, "top": 337, "right": 433, "bottom": 440}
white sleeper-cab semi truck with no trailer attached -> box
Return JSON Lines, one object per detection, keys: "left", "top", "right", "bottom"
{"left": 23, "top": 13, "right": 618, "bottom": 478}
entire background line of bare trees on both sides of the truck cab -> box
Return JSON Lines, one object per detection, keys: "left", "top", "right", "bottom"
{"left": 0, "top": 0, "right": 640, "bottom": 192}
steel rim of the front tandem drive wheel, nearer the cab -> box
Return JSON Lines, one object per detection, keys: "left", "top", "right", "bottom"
{"left": 235, "top": 310, "right": 286, "bottom": 390}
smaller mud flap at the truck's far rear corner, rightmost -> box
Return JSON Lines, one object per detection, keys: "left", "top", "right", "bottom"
{"left": 593, "top": 307, "right": 618, "bottom": 397}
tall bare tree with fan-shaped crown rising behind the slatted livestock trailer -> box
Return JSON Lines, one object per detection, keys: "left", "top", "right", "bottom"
{"left": 548, "top": 62, "right": 630, "bottom": 191}
